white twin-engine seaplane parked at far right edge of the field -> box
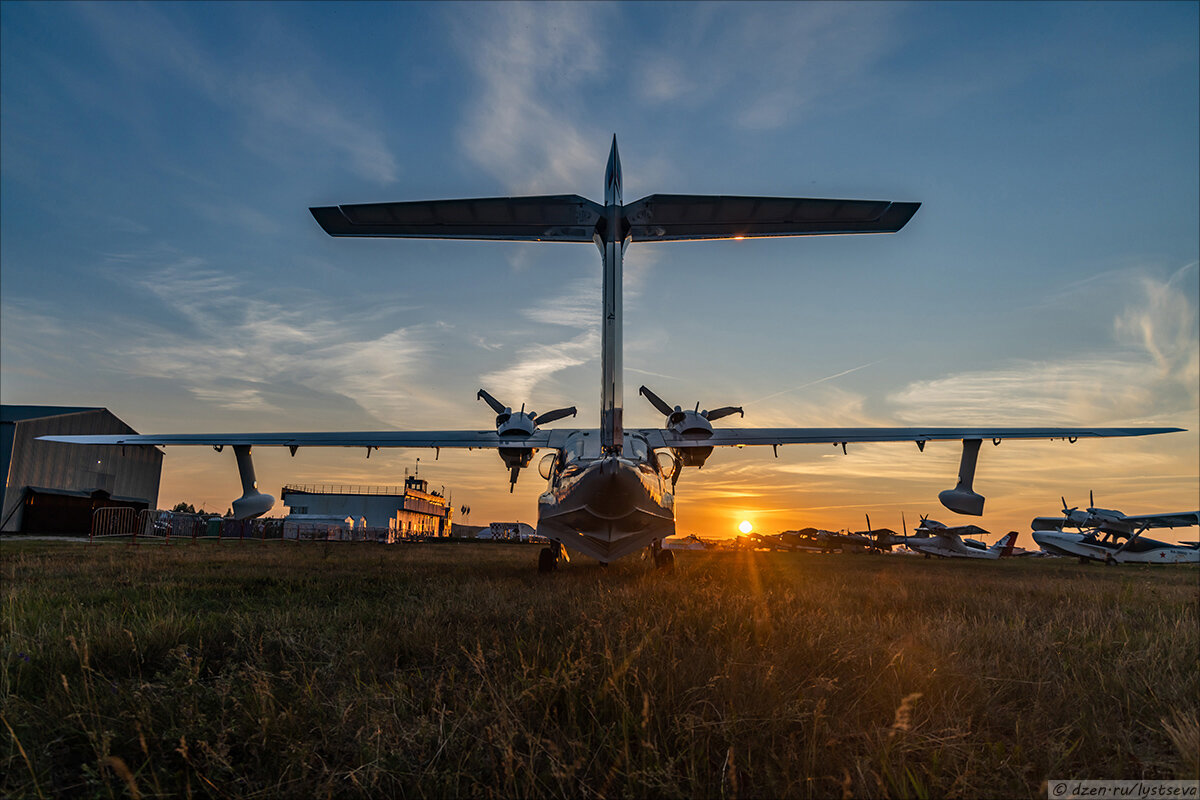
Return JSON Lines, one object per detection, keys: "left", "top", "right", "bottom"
{"left": 1031, "top": 492, "right": 1200, "bottom": 564}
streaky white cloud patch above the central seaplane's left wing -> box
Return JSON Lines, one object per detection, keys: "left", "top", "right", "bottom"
{"left": 88, "top": 252, "right": 431, "bottom": 426}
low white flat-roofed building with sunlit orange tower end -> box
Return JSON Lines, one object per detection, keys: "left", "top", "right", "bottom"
{"left": 280, "top": 475, "right": 454, "bottom": 536}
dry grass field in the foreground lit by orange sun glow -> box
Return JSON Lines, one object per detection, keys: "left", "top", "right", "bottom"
{"left": 0, "top": 542, "right": 1200, "bottom": 798}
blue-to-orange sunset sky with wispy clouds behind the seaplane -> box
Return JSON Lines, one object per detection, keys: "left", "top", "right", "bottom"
{"left": 0, "top": 1, "right": 1200, "bottom": 547}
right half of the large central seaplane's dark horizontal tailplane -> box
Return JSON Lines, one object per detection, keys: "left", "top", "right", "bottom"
{"left": 624, "top": 194, "right": 920, "bottom": 241}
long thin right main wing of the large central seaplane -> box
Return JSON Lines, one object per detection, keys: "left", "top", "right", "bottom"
{"left": 640, "top": 427, "right": 1183, "bottom": 447}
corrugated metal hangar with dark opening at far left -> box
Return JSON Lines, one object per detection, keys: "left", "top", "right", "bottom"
{"left": 0, "top": 405, "right": 162, "bottom": 534}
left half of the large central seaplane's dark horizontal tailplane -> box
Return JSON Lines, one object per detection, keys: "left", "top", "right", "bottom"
{"left": 310, "top": 194, "right": 604, "bottom": 242}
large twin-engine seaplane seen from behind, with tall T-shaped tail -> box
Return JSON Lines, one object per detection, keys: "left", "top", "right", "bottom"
{"left": 35, "top": 136, "right": 1181, "bottom": 572}
